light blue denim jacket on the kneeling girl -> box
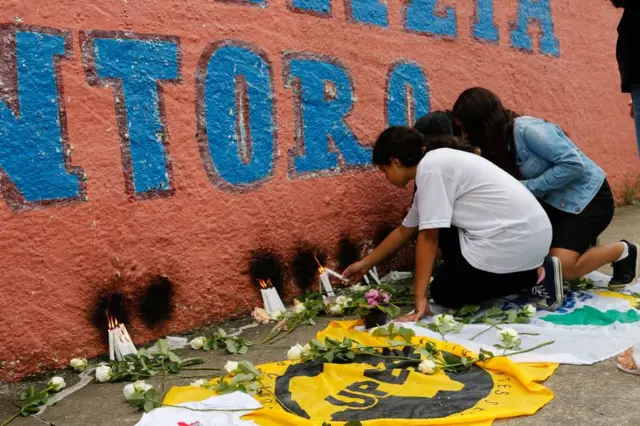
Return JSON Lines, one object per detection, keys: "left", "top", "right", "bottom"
{"left": 513, "top": 117, "right": 605, "bottom": 214}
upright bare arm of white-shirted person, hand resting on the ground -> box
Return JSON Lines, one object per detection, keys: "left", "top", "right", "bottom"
{"left": 397, "top": 228, "right": 439, "bottom": 322}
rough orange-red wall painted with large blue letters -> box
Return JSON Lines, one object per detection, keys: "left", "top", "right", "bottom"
{"left": 0, "top": 0, "right": 640, "bottom": 379}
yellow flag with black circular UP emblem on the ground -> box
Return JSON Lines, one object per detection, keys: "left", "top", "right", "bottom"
{"left": 165, "top": 322, "right": 557, "bottom": 426}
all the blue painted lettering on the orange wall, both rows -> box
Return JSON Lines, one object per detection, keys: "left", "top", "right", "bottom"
{"left": 0, "top": 0, "right": 559, "bottom": 211}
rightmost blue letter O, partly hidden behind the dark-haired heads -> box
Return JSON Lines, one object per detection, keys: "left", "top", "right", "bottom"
{"left": 387, "top": 63, "right": 430, "bottom": 126}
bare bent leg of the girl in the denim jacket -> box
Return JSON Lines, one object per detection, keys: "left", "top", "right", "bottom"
{"left": 550, "top": 243, "right": 624, "bottom": 280}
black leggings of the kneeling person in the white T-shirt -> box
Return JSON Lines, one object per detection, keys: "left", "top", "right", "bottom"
{"left": 429, "top": 227, "right": 538, "bottom": 309}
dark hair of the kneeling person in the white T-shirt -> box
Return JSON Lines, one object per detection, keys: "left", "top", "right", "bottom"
{"left": 372, "top": 126, "right": 473, "bottom": 167}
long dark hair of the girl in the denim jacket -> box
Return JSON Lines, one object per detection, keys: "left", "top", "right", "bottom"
{"left": 452, "top": 87, "right": 520, "bottom": 179}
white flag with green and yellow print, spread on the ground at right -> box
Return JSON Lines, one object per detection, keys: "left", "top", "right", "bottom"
{"left": 396, "top": 272, "right": 640, "bottom": 365}
